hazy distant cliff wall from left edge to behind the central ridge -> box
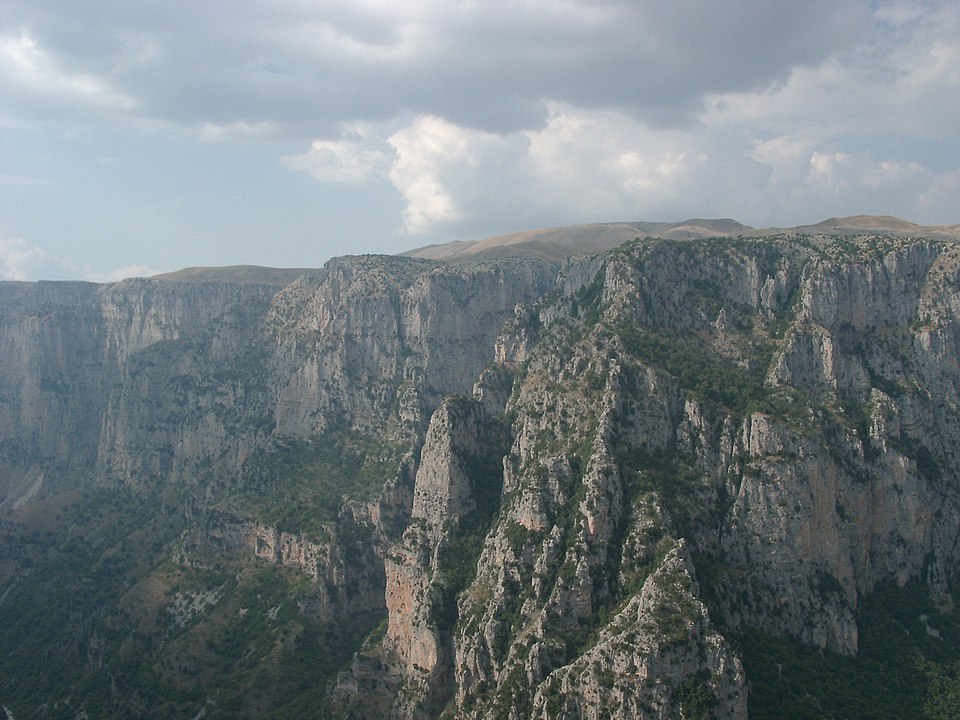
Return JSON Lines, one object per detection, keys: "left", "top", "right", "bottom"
{"left": 0, "top": 257, "right": 553, "bottom": 505}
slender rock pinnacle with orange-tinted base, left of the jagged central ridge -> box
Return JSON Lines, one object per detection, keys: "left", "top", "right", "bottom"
{"left": 338, "top": 397, "right": 506, "bottom": 718}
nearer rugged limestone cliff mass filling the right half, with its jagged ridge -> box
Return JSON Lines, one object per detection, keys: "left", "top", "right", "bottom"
{"left": 336, "top": 237, "right": 960, "bottom": 718}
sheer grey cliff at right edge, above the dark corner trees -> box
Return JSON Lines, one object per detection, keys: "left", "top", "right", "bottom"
{"left": 721, "top": 241, "right": 960, "bottom": 652}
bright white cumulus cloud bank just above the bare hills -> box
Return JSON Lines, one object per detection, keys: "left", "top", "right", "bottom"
{"left": 285, "top": 97, "right": 960, "bottom": 237}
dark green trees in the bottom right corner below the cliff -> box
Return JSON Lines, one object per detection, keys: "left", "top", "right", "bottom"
{"left": 742, "top": 582, "right": 960, "bottom": 720}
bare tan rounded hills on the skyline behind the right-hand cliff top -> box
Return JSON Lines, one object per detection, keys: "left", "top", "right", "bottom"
{"left": 402, "top": 215, "right": 960, "bottom": 262}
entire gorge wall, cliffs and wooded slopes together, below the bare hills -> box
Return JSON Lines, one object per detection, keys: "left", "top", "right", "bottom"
{"left": 0, "top": 226, "right": 960, "bottom": 720}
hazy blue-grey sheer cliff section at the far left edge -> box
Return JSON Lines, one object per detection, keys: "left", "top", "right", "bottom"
{"left": 0, "top": 280, "right": 286, "bottom": 505}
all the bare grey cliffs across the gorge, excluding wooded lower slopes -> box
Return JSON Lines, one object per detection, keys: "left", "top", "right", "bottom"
{"left": 0, "top": 234, "right": 960, "bottom": 719}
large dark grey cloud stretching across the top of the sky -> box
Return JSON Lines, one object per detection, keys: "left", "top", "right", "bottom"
{"left": 0, "top": 0, "right": 870, "bottom": 136}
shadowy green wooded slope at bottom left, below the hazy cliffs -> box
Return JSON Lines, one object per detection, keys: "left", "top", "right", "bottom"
{"left": 0, "top": 490, "right": 381, "bottom": 720}
